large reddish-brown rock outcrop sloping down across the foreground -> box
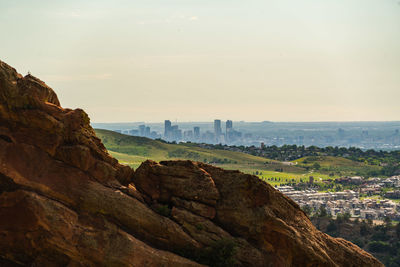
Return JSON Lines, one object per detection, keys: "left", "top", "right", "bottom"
{"left": 0, "top": 61, "right": 382, "bottom": 266}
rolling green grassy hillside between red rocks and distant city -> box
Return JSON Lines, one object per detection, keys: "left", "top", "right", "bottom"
{"left": 95, "top": 129, "right": 380, "bottom": 185}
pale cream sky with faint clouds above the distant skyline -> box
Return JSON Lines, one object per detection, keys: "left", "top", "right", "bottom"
{"left": 0, "top": 0, "right": 400, "bottom": 122}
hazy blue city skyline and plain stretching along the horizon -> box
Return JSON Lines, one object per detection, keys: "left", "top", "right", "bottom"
{"left": 104, "top": 119, "right": 400, "bottom": 150}
